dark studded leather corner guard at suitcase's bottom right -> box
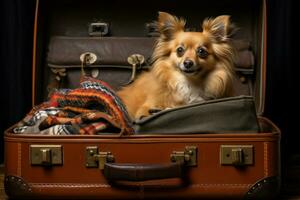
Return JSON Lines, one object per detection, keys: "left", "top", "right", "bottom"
{"left": 244, "top": 176, "right": 280, "bottom": 200}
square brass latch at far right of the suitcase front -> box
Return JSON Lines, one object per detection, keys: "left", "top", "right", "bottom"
{"left": 220, "top": 145, "right": 254, "bottom": 166}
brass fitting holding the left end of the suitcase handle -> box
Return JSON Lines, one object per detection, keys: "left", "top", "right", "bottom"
{"left": 86, "top": 146, "right": 115, "bottom": 169}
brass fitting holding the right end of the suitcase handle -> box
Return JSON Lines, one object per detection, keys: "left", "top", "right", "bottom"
{"left": 170, "top": 146, "right": 197, "bottom": 167}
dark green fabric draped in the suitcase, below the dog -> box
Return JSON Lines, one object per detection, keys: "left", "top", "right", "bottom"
{"left": 134, "top": 96, "right": 260, "bottom": 134}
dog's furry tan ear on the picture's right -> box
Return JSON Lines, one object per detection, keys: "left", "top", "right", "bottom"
{"left": 202, "top": 15, "right": 234, "bottom": 42}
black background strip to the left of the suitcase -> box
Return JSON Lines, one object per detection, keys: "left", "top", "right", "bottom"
{"left": 0, "top": 0, "right": 35, "bottom": 159}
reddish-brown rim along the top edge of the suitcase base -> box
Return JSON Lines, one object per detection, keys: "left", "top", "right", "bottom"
{"left": 5, "top": 133, "right": 279, "bottom": 143}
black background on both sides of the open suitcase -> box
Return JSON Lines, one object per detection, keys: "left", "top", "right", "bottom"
{"left": 0, "top": 0, "right": 300, "bottom": 194}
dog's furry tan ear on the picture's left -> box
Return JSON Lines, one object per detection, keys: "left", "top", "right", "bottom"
{"left": 157, "top": 12, "right": 185, "bottom": 40}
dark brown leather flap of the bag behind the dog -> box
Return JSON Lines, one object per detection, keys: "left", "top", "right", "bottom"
{"left": 47, "top": 36, "right": 255, "bottom": 69}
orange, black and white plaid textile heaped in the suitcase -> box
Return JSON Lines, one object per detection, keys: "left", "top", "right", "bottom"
{"left": 14, "top": 77, "right": 134, "bottom": 135}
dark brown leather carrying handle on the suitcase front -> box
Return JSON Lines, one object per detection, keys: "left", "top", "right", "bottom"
{"left": 103, "top": 162, "right": 185, "bottom": 181}
